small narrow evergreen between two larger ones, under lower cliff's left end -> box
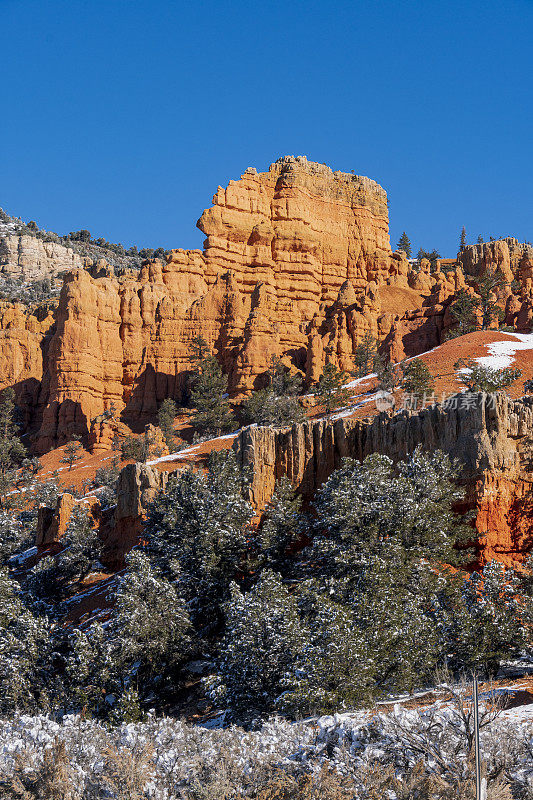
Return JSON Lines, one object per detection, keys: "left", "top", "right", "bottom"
{"left": 258, "top": 477, "right": 304, "bottom": 569}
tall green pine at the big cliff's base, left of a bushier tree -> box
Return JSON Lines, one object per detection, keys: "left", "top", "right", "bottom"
{"left": 191, "top": 355, "right": 235, "bottom": 436}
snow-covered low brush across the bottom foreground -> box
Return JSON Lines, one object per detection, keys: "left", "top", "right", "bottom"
{"left": 0, "top": 702, "right": 533, "bottom": 800}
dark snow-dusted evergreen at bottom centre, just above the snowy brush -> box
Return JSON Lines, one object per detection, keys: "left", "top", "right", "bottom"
{"left": 206, "top": 570, "right": 308, "bottom": 721}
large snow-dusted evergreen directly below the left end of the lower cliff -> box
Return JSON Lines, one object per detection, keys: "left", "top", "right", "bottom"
{"left": 145, "top": 451, "right": 253, "bottom": 624}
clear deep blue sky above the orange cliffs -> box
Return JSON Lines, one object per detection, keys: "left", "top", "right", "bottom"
{"left": 0, "top": 0, "right": 533, "bottom": 255}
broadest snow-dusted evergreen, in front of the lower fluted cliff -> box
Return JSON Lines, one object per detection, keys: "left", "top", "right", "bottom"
{"left": 306, "top": 449, "right": 472, "bottom": 688}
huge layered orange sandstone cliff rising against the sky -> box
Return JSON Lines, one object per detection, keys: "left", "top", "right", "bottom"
{"left": 0, "top": 156, "right": 533, "bottom": 453}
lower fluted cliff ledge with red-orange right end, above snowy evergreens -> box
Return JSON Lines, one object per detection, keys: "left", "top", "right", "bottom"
{"left": 234, "top": 393, "right": 533, "bottom": 565}
